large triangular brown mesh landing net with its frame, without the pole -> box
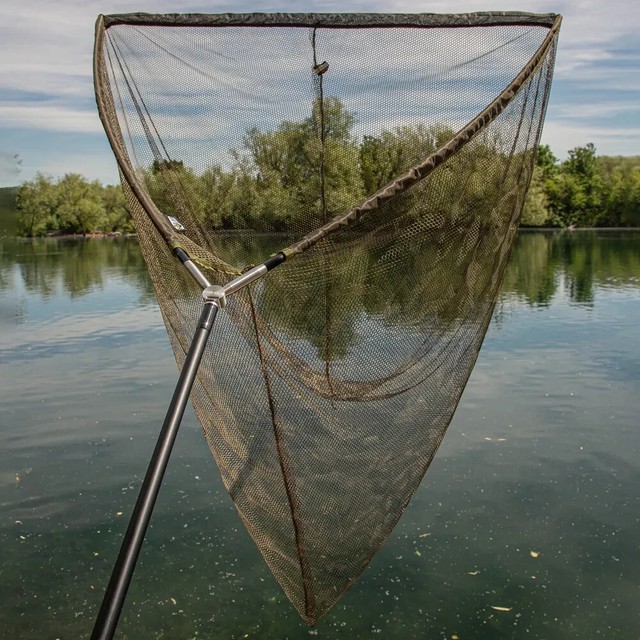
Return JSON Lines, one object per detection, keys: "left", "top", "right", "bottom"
{"left": 95, "top": 13, "right": 560, "bottom": 623}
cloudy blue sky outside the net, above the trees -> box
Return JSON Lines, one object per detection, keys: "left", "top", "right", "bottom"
{"left": 0, "top": 0, "right": 640, "bottom": 187}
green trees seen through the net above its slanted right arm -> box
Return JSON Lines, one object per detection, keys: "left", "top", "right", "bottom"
{"left": 140, "top": 102, "right": 462, "bottom": 232}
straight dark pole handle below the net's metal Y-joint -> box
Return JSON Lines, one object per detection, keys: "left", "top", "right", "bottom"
{"left": 91, "top": 299, "right": 218, "bottom": 640}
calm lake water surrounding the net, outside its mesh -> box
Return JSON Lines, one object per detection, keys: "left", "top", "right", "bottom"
{"left": 0, "top": 232, "right": 640, "bottom": 640}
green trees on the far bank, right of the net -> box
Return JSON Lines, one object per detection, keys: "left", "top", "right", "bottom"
{"left": 522, "top": 143, "right": 640, "bottom": 227}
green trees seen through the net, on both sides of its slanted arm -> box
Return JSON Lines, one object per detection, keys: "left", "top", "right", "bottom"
{"left": 145, "top": 97, "right": 533, "bottom": 233}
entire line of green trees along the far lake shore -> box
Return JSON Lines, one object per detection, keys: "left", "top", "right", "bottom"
{"left": 17, "top": 97, "right": 640, "bottom": 236}
